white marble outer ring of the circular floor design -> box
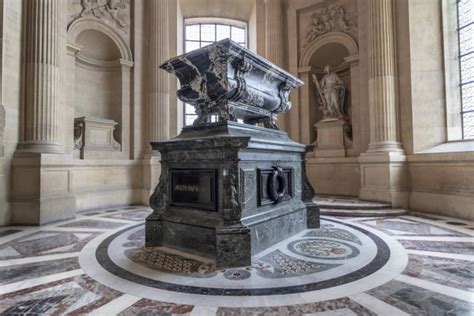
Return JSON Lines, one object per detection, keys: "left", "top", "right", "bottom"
{"left": 79, "top": 219, "right": 408, "bottom": 307}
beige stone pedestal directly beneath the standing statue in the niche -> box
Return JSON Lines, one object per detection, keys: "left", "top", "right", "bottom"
{"left": 314, "top": 119, "right": 346, "bottom": 157}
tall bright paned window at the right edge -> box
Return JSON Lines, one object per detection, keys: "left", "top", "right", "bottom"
{"left": 456, "top": 0, "right": 474, "bottom": 139}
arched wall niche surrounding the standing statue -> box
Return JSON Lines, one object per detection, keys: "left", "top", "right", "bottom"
{"left": 298, "top": 32, "right": 360, "bottom": 156}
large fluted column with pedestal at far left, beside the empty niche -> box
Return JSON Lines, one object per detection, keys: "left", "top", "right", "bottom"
{"left": 11, "top": 0, "right": 76, "bottom": 225}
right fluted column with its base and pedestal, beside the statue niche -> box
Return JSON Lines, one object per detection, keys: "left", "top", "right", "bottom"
{"left": 359, "top": 0, "right": 408, "bottom": 207}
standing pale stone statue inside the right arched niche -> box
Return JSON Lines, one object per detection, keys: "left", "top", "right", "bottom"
{"left": 313, "top": 65, "right": 346, "bottom": 120}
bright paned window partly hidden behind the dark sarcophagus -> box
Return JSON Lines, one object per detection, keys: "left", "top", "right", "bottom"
{"left": 183, "top": 18, "right": 247, "bottom": 126}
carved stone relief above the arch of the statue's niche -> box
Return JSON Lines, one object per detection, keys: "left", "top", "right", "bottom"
{"left": 303, "top": 4, "right": 357, "bottom": 47}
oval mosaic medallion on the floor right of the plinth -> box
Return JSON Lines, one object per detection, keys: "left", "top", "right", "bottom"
{"left": 288, "top": 239, "right": 360, "bottom": 259}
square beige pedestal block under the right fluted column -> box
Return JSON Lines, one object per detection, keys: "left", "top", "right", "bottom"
{"left": 358, "top": 151, "right": 409, "bottom": 208}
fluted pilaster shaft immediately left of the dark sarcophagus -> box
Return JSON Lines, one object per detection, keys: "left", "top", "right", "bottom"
{"left": 147, "top": 0, "right": 170, "bottom": 152}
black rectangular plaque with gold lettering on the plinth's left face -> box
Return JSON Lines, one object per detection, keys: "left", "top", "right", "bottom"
{"left": 170, "top": 169, "right": 217, "bottom": 211}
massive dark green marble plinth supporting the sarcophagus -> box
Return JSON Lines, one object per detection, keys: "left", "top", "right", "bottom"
{"left": 146, "top": 122, "right": 319, "bottom": 267}
